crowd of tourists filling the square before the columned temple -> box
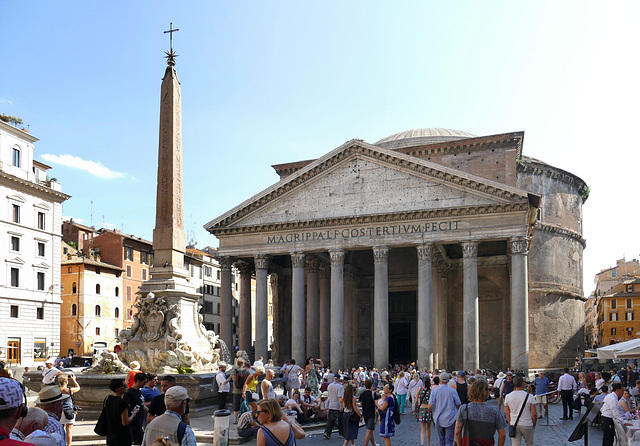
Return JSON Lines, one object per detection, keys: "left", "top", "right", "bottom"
{"left": 0, "top": 357, "right": 640, "bottom": 446}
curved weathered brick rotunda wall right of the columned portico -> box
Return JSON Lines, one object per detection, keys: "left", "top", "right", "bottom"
{"left": 517, "top": 159, "right": 586, "bottom": 369}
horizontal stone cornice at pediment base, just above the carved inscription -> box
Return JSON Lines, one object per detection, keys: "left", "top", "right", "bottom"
{"left": 209, "top": 201, "right": 529, "bottom": 236}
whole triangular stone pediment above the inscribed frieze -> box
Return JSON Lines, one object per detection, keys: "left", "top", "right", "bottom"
{"left": 205, "top": 140, "right": 528, "bottom": 232}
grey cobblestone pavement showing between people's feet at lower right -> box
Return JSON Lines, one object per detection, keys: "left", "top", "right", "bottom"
{"left": 298, "top": 400, "right": 602, "bottom": 446}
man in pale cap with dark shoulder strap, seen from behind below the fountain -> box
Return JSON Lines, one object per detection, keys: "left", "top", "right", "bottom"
{"left": 142, "top": 386, "right": 196, "bottom": 446}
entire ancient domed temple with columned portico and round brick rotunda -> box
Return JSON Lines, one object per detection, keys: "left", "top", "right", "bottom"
{"left": 205, "top": 128, "right": 588, "bottom": 371}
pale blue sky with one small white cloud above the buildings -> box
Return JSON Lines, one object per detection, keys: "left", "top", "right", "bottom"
{"left": 0, "top": 0, "right": 640, "bottom": 294}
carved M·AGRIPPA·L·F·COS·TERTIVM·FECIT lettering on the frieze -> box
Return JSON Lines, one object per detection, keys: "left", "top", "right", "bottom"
{"left": 267, "top": 220, "right": 461, "bottom": 243}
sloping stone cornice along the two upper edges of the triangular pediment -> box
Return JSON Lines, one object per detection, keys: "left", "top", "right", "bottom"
{"left": 204, "top": 140, "right": 528, "bottom": 235}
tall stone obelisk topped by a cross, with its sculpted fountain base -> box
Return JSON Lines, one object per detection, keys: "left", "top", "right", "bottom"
{"left": 125, "top": 26, "right": 216, "bottom": 362}
